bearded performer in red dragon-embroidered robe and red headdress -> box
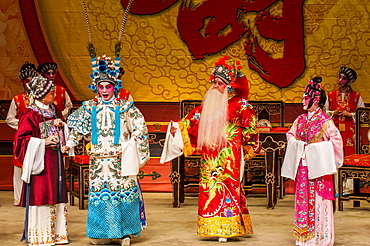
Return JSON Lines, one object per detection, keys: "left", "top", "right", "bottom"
{"left": 161, "top": 56, "right": 258, "bottom": 242}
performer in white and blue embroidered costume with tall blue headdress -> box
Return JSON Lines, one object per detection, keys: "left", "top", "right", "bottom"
{"left": 66, "top": 56, "right": 149, "bottom": 245}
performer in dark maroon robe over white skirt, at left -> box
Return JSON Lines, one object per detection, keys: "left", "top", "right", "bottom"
{"left": 15, "top": 76, "right": 68, "bottom": 245}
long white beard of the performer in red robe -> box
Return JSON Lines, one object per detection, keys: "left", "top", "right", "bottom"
{"left": 197, "top": 86, "right": 228, "bottom": 149}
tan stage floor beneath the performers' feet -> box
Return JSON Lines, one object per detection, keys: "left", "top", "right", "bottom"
{"left": 0, "top": 191, "right": 370, "bottom": 246}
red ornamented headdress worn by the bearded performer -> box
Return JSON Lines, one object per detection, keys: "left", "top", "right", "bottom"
{"left": 209, "top": 56, "right": 249, "bottom": 99}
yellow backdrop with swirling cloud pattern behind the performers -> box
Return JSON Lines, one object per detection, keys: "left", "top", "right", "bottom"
{"left": 0, "top": 0, "right": 370, "bottom": 103}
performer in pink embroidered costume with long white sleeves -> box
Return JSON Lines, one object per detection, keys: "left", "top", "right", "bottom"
{"left": 281, "top": 77, "right": 343, "bottom": 245}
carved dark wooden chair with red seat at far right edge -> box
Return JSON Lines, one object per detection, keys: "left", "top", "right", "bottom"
{"left": 338, "top": 108, "right": 370, "bottom": 211}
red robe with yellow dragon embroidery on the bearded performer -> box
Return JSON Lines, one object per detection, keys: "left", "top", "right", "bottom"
{"left": 180, "top": 97, "right": 258, "bottom": 238}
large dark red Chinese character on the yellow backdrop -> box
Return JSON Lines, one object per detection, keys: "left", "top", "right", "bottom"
{"left": 121, "top": 0, "right": 305, "bottom": 88}
